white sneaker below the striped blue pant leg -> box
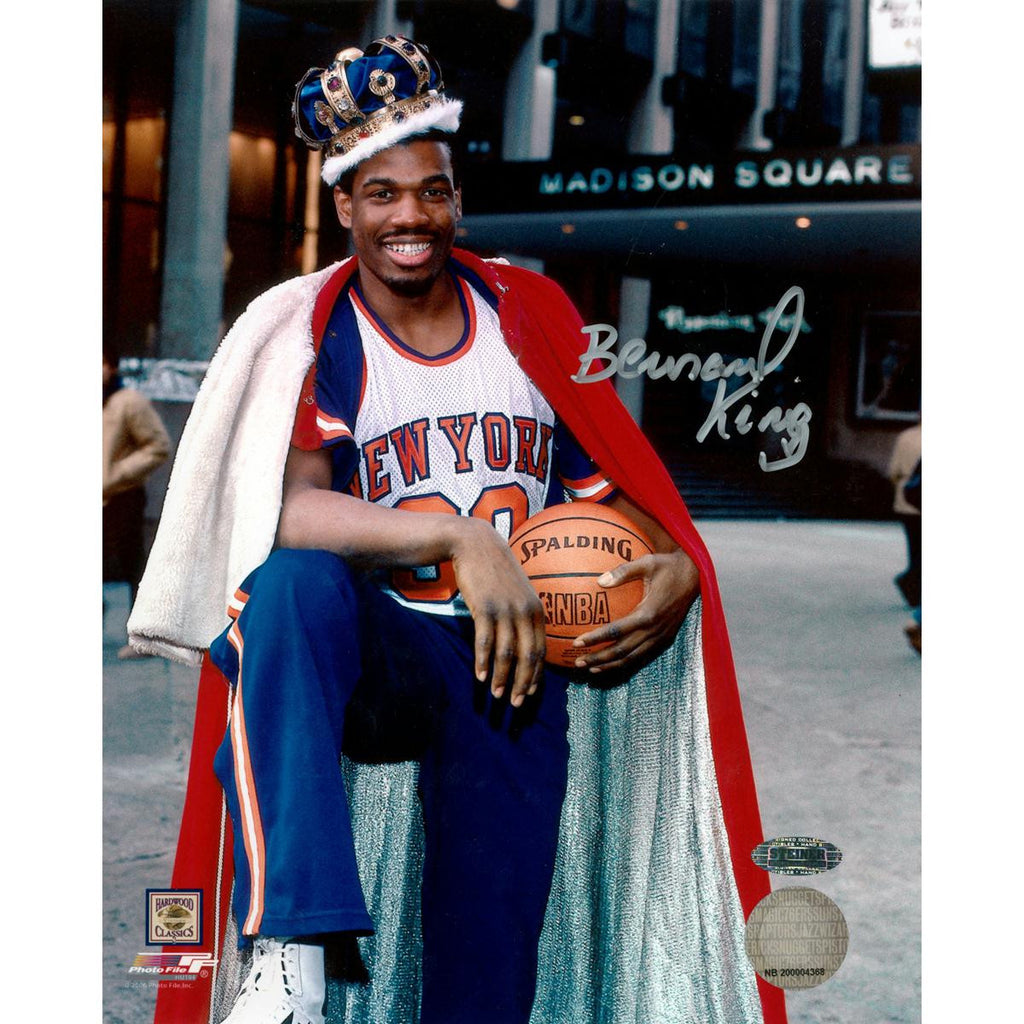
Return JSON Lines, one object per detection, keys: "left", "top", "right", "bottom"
{"left": 221, "top": 937, "right": 327, "bottom": 1024}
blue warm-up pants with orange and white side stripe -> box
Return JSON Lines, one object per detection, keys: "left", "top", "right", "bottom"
{"left": 210, "top": 550, "right": 568, "bottom": 1024}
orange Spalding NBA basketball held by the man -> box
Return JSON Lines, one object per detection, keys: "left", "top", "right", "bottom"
{"left": 509, "top": 502, "right": 653, "bottom": 668}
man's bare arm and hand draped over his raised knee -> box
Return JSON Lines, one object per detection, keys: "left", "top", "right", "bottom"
{"left": 278, "top": 446, "right": 545, "bottom": 707}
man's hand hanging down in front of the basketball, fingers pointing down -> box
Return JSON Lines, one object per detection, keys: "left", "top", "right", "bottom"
{"left": 452, "top": 518, "right": 546, "bottom": 708}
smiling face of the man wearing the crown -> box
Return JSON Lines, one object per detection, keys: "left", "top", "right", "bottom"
{"left": 334, "top": 140, "right": 462, "bottom": 296}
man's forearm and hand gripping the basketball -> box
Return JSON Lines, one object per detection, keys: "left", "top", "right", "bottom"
{"left": 574, "top": 494, "right": 700, "bottom": 673}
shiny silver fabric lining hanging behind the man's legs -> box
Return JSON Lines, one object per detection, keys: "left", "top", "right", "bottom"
{"left": 213, "top": 601, "right": 762, "bottom": 1024}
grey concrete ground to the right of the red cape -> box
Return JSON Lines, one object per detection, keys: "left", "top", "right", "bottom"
{"left": 699, "top": 521, "right": 921, "bottom": 1024}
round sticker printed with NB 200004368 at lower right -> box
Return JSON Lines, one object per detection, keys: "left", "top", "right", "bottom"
{"left": 744, "top": 886, "right": 850, "bottom": 988}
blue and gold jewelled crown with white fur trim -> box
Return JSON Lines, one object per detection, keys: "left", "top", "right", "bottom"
{"left": 292, "top": 36, "right": 462, "bottom": 185}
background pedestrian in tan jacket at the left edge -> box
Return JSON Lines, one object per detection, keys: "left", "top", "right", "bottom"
{"left": 103, "top": 350, "right": 171, "bottom": 658}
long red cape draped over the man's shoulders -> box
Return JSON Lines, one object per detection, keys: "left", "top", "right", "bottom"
{"left": 155, "top": 249, "right": 786, "bottom": 1024}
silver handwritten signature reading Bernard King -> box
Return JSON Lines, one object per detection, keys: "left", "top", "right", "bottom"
{"left": 571, "top": 287, "right": 811, "bottom": 473}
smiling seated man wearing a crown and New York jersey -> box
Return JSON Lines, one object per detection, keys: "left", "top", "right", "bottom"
{"left": 134, "top": 37, "right": 782, "bottom": 1024}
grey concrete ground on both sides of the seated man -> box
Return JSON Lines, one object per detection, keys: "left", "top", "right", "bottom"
{"left": 103, "top": 521, "right": 921, "bottom": 1024}
